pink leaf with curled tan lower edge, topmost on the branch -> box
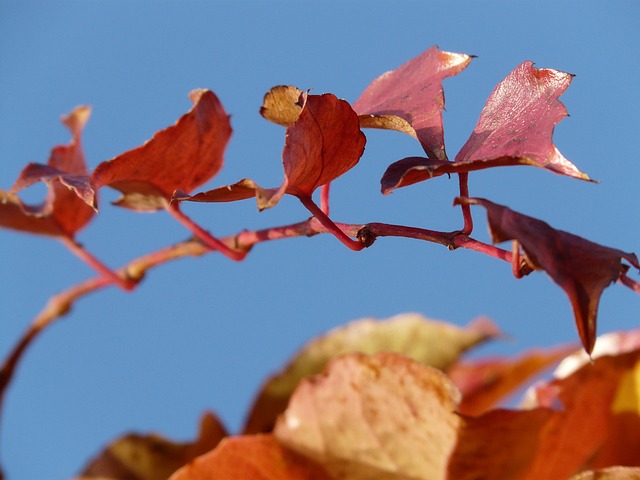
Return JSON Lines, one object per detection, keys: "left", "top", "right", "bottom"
{"left": 353, "top": 46, "right": 472, "bottom": 160}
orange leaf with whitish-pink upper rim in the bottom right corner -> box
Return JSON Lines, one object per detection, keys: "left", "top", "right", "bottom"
{"left": 523, "top": 338, "right": 640, "bottom": 480}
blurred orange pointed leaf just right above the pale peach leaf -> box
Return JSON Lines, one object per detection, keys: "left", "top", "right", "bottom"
{"left": 446, "top": 346, "right": 575, "bottom": 416}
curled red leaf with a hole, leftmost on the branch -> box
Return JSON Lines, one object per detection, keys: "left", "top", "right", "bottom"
{"left": 0, "top": 106, "right": 96, "bottom": 238}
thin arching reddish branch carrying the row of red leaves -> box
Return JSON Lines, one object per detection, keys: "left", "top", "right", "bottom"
{"left": 0, "top": 214, "right": 640, "bottom": 476}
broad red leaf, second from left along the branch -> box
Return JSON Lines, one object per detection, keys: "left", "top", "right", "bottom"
{"left": 91, "top": 90, "right": 231, "bottom": 211}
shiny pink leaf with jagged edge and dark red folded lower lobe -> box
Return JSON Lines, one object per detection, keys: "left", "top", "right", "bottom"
{"left": 382, "top": 62, "right": 591, "bottom": 193}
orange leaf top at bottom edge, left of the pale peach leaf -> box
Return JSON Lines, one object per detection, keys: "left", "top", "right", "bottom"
{"left": 170, "top": 435, "right": 330, "bottom": 480}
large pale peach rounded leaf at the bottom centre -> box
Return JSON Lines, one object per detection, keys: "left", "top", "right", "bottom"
{"left": 275, "top": 353, "right": 460, "bottom": 480}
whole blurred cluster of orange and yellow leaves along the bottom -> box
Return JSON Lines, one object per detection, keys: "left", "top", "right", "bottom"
{"left": 79, "top": 314, "right": 640, "bottom": 480}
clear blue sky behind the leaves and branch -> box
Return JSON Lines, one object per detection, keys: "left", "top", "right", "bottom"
{"left": 0, "top": 0, "right": 640, "bottom": 480}
